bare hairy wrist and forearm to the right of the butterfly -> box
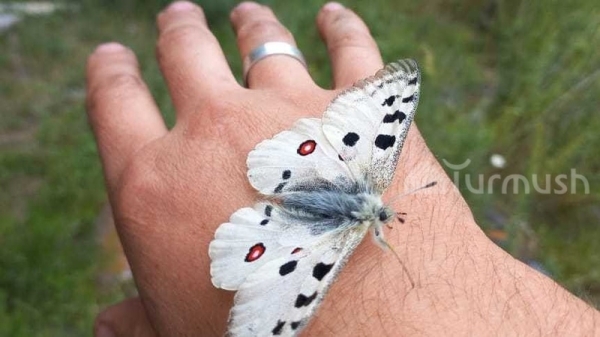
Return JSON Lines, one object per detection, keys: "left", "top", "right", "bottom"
{"left": 310, "top": 125, "right": 600, "bottom": 335}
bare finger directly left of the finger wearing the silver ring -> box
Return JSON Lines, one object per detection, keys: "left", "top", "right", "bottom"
{"left": 157, "top": 1, "right": 239, "bottom": 116}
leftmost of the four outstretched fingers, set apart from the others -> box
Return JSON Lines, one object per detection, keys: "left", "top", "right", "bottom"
{"left": 86, "top": 43, "right": 167, "bottom": 190}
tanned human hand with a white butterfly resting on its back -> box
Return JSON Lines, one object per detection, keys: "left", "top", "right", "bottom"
{"left": 88, "top": 2, "right": 600, "bottom": 336}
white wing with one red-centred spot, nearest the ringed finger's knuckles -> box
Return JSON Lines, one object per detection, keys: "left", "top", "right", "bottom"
{"left": 247, "top": 118, "right": 352, "bottom": 195}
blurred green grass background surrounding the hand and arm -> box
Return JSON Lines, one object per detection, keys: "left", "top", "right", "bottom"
{"left": 0, "top": 0, "right": 600, "bottom": 336}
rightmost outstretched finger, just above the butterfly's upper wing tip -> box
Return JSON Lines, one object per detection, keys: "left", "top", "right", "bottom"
{"left": 317, "top": 2, "right": 383, "bottom": 88}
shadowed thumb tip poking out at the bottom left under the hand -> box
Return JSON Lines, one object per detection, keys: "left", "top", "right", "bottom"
{"left": 94, "top": 297, "right": 157, "bottom": 337}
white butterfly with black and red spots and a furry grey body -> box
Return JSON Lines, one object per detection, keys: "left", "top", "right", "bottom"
{"left": 209, "top": 60, "right": 420, "bottom": 336}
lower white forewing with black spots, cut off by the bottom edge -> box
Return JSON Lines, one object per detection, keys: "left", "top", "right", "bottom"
{"left": 228, "top": 226, "right": 367, "bottom": 337}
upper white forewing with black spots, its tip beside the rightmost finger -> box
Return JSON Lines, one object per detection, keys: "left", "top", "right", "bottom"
{"left": 323, "top": 60, "right": 420, "bottom": 192}
